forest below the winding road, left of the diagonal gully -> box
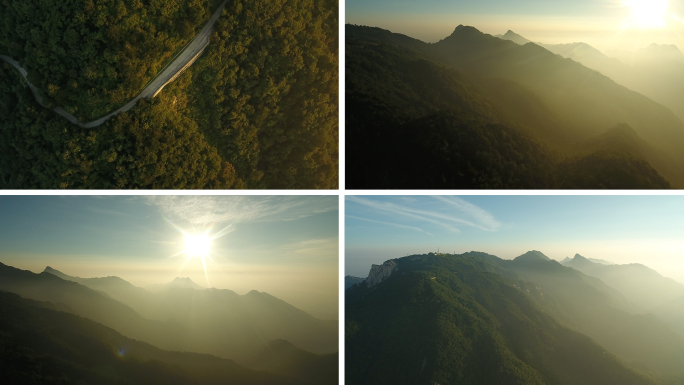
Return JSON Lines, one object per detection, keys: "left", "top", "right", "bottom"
{"left": 0, "top": 62, "right": 236, "bottom": 189}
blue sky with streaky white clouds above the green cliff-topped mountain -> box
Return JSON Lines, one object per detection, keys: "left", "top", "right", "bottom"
{"left": 345, "top": 195, "right": 684, "bottom": 283}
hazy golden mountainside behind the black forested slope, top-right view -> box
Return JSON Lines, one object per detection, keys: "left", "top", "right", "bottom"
{"left": 429, "top": 26, "right": 684, "bottom": 185}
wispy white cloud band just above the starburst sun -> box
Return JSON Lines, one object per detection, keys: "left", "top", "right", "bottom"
{"left": 143, "top": 195, "right": 337, "bottom": 225}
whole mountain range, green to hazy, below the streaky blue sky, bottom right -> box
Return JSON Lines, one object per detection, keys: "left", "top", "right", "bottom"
{"left": 345, "top": 252, "right": 684, "bottom": 384}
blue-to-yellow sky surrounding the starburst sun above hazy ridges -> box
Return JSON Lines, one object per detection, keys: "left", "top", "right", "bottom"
{"left": 0, "top": 196, "right": 339, "bottom": 316}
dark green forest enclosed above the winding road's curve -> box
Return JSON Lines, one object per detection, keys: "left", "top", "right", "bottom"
{"left": 0, "top": 0, "right": 219, "bottom": 122}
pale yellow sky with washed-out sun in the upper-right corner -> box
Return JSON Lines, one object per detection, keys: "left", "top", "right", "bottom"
{"left": 345, "top": 0, "right": 684, "bottom": 52}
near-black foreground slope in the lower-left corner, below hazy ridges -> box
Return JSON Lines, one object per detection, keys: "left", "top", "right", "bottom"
{"left": 0, "top": 292, "right": 294, "bottom": 385}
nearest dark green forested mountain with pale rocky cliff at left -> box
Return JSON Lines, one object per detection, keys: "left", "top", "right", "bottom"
{"left": 345, "top": 253, "right": 654, "bottom": 384}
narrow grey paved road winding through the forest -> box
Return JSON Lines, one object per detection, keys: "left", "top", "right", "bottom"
{"left": 0, "top": 0, "right": 228, "bottom": 128}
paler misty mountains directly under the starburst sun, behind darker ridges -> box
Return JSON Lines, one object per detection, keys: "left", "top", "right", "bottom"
{"left": 40, "top": 269, "right": 338, "bottom": 362}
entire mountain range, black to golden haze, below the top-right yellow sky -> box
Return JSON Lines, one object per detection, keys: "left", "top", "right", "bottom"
{"left": 346, "top": 25, "right": 684, "bottom": 188}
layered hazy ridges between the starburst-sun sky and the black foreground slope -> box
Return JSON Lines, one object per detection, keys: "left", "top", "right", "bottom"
{"left": 0, "top": 265, "right": 337, "bottom": 384}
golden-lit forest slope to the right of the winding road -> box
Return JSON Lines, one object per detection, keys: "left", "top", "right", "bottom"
{"left": 191, "top": 0, "right": 338, "bottom": 188}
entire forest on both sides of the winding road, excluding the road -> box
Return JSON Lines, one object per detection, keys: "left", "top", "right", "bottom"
{"left": 0, "top": 0, "right": 338, "bottom": 189}
